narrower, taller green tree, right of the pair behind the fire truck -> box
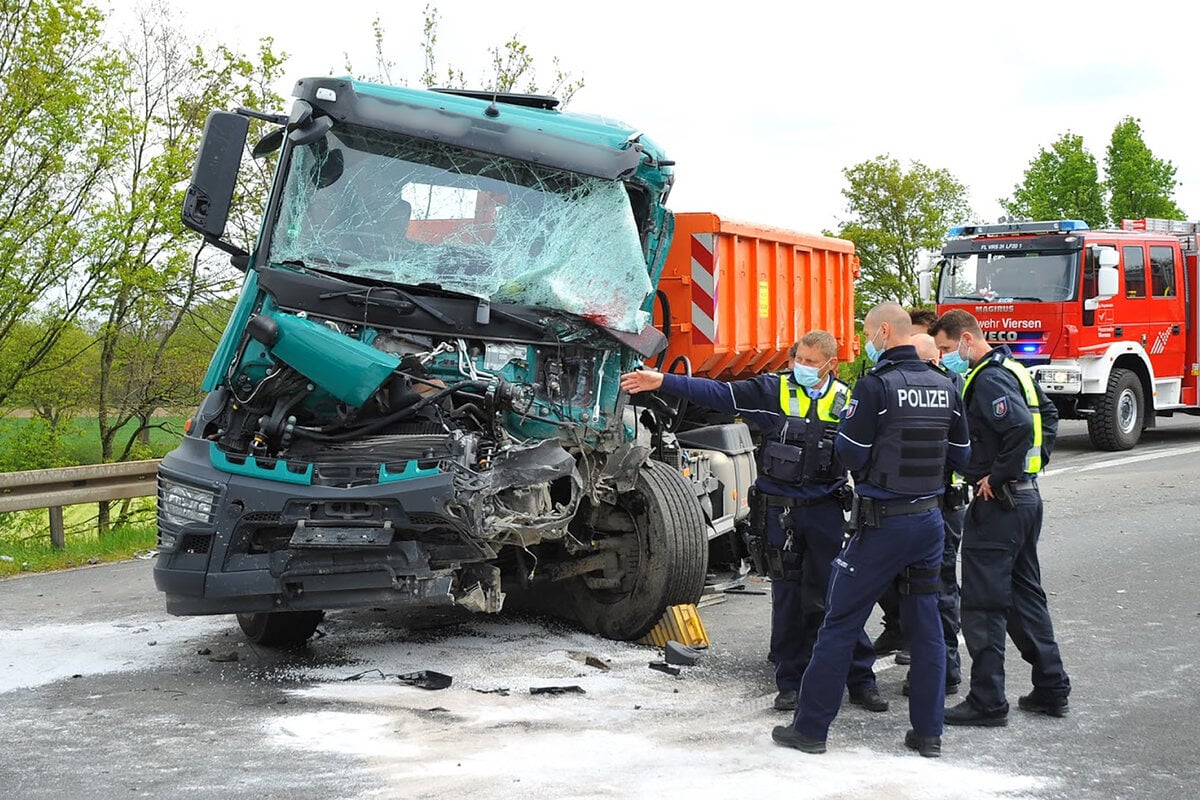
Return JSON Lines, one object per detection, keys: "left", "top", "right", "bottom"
{"left": 1104, "top": 116, "right": 1187, "bottom": 224}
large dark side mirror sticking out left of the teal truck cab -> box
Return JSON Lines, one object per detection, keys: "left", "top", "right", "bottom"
{"left": 184, "top": 112, "right": 250, "bottom": 253}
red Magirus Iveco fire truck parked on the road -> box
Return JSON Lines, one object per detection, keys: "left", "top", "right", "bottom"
{"left": 922, "top": 218, "right": 1200, "bottom": 450}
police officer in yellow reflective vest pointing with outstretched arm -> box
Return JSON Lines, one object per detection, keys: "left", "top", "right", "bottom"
{"left": 620, "top": 331, "right": 888, "bottom": 711}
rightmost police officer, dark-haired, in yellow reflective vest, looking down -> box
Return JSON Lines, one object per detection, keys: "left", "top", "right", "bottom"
{"left": 934, "top": 309, "right": 1070, "bottom": 727}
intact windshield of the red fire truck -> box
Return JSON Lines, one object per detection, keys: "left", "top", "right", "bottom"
{"left": 937, "top": 251, "right": 1079, "bottom": 302}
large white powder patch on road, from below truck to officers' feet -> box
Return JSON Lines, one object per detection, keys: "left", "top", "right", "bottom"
{"left": 266, "top": 622, "right": 1046, "bottom": 800}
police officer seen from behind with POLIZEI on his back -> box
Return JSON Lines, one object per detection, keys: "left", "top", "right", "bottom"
{"left": 772, "top": 303, "right": 971, "bottom": 757}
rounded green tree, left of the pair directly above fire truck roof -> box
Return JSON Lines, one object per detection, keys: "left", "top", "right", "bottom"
{"left": 1000, "top": 132, "right": 1108, "bottom": 228}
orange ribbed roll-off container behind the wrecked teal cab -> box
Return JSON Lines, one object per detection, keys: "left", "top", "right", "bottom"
{"left": 652, "top": 212, "right": 859, "bottom": 380}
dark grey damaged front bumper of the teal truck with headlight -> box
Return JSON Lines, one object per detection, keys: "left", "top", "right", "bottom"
{"left": 154, "top": 438, "right": 496, "bottom": 615}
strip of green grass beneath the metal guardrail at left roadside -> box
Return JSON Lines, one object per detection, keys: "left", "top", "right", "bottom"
{"left": 0, "top": 498, "right": 157, "bottom": 578}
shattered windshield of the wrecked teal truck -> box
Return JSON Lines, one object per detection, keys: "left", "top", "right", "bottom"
{"left": 269, "top": 127, "right": 652, "bottom": 332}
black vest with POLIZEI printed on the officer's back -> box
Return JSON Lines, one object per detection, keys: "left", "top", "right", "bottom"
{"left": 863, "top": 363, "right": 954, "bottom": 495}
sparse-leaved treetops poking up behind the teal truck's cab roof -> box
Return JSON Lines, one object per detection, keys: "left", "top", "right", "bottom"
{"left": 357, "top": 5, "right": 584, "bottom": 107}
